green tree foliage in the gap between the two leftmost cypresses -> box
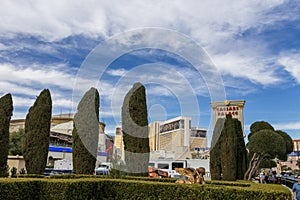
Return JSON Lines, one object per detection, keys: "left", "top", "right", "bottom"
{"left": 9, "top": 129, "right": 25, "bottom": 156}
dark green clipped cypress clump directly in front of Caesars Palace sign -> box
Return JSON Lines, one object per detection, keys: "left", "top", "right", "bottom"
{"left": 210, "top": 115, "right": 247, "bottom": 180}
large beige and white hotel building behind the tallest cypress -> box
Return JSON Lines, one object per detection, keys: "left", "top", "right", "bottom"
{"left": 114, "top": 116, "right": 208, "bottom": 160}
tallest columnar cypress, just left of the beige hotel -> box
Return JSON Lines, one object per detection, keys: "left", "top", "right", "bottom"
{"left": 122, "top": 83, "right": 150, "bottom": 176}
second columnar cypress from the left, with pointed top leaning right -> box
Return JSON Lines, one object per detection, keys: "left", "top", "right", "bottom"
{"left": 23, "top": 89, "right": 52, "bottom": 174}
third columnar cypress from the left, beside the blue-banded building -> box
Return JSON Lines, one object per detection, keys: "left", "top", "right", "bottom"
{"left": 72, "top": 88, "right": 99, "bottom": 174}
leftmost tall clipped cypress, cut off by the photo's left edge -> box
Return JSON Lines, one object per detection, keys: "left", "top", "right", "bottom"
{"left": 0, "top": 94, "right": 13, "bottom": 177}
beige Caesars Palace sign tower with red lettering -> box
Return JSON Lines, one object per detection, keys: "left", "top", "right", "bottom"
{"left": 210, "top": 100, "right": 246, "bottom": 137}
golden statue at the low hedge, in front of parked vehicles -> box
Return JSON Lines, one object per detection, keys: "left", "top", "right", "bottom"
{"left": 175, "top": 167, "right": 205, "bottom": 184}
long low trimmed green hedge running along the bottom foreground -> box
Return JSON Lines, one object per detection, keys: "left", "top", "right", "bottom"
{"left": 0, "top": 178, "right": 291, "bottom": 200}
